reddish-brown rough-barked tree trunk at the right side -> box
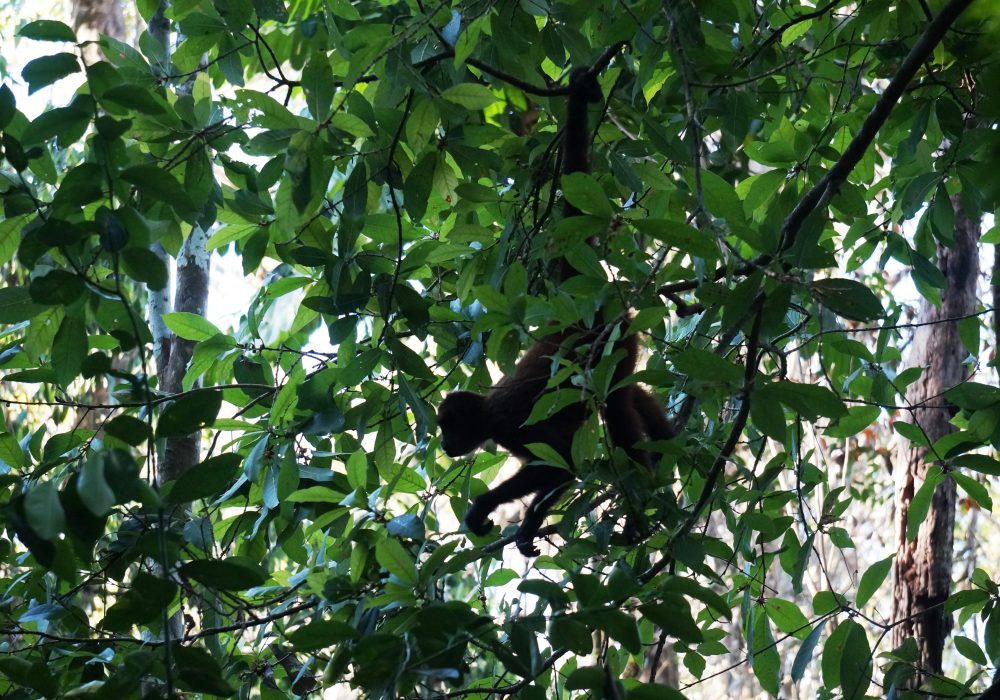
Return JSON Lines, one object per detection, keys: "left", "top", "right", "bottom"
{"left": 892, "top": 197, "right": 979, "bottom": 684}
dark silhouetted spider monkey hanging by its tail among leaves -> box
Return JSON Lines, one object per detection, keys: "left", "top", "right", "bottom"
{"left": 437, "top": 68, "right": 677, "bottom": 557}
